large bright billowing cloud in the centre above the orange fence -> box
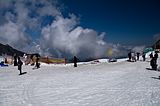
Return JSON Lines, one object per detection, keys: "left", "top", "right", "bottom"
{"left": 41, "top": 15, "right": 106, "bottom": 58}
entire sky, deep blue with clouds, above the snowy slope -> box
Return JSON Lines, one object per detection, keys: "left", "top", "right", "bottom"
{"left": 0, "top": 0, "right": 160, "bottom": 58}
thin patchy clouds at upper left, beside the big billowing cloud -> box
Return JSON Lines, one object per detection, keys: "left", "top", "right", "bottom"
{"left": 0, "top": 0, "right": 58, "bottom": 51}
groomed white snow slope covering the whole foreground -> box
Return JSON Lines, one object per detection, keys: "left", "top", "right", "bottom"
{"left": 0, "top": 56, "right": 160, "bottom": 106}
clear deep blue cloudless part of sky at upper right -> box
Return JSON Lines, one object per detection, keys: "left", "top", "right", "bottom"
{"left": 61, "top": 0, "right": 160, "bottom": 45}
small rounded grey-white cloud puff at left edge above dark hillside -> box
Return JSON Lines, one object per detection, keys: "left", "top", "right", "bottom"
{"left": 0, "top": 21, "right": 29, "bottom": 49}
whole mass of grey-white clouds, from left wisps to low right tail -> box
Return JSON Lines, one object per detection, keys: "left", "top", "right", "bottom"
{"left": 0, "top": 0, "right": 136, "bottom": 59}
